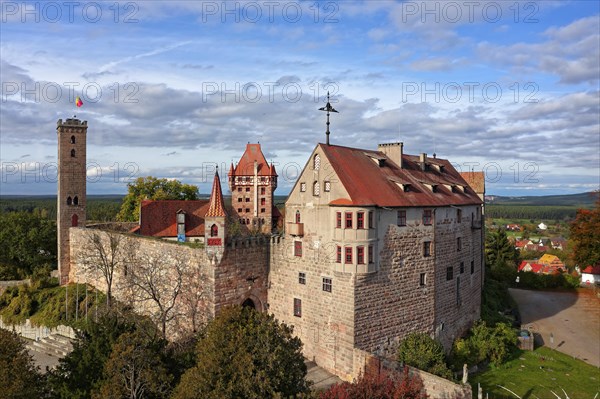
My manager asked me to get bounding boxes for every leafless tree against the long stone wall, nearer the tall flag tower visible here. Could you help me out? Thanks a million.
[79,230,134,307]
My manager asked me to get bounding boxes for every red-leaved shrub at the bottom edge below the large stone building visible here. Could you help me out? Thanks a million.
[320,367,428,399]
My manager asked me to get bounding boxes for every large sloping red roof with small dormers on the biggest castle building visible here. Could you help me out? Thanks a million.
[318,144,482,207]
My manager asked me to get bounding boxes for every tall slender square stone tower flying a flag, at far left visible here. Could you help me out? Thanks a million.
[56,118,87,284]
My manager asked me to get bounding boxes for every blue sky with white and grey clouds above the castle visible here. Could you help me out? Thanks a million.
[0,0,600,196]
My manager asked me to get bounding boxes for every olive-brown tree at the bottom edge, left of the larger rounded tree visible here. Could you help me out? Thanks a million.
[92,330,172,399]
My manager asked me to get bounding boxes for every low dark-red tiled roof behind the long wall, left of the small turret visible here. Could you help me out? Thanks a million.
[139,200,209,237]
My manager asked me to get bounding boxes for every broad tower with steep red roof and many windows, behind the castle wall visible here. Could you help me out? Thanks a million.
[229,143,279,234]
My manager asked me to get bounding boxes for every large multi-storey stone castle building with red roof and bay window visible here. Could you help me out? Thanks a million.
[269,143,483,378]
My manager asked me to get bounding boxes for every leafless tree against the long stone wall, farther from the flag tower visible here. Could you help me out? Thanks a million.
[126,252,188,338]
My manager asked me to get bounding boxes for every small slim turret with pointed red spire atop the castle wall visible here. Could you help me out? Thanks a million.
[204,171,227,259]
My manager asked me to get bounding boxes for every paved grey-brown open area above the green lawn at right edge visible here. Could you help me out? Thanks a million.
[509,288,600,367]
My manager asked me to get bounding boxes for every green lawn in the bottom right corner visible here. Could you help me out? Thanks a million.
[469,347,600,399]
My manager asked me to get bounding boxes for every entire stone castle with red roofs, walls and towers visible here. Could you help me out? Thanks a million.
[57,119,484,379]
